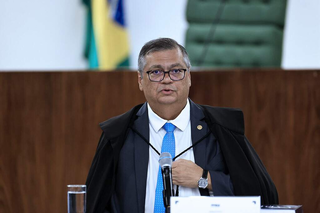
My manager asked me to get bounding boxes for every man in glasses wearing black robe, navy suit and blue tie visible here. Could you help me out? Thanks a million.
[86,38,278,213]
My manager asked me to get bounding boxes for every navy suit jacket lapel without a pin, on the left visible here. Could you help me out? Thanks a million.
[133,103,149,212]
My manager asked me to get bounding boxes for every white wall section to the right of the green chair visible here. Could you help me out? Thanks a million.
[282,0,320,69]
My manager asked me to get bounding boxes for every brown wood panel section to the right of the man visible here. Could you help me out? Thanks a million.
[190,71,320,213]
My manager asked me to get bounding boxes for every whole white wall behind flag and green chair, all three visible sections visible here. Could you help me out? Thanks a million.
[0,0,320,70]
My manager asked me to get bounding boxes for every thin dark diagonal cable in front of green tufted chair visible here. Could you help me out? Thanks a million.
[196,0,226,67]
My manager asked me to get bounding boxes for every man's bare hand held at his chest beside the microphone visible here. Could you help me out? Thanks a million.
[172,159,203,188]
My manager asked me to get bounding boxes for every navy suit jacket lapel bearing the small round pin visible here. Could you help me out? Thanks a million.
[190,100,208,168]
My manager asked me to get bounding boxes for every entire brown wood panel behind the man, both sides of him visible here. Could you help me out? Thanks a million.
[0,70,320,213]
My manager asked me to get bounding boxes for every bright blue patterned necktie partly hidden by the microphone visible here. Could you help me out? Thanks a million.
[154,123,176,213]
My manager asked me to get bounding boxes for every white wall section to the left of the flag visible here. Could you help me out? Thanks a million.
[0,0,86,70]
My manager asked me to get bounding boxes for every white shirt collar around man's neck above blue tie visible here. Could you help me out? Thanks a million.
[147,101,190,132]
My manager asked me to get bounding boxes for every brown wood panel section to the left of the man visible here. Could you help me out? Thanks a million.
[0,72,144,213]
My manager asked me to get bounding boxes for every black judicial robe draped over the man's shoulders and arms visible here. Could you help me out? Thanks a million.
[86,101,278,213]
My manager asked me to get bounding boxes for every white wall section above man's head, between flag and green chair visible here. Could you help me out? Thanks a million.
[125,0,187,69]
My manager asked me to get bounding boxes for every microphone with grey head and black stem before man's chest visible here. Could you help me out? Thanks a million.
[159,152,174,212]
